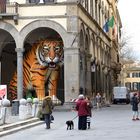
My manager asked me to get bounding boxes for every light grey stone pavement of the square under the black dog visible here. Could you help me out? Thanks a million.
[2,104,140,140]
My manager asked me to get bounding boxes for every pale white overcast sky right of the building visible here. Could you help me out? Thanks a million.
[118,0,140,61]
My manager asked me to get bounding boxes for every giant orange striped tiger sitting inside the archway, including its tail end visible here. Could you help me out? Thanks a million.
[9,39,63,100]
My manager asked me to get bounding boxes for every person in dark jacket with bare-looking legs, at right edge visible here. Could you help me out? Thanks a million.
[131,93,139,121]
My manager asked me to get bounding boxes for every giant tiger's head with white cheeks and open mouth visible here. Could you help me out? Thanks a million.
[36,40,63,68]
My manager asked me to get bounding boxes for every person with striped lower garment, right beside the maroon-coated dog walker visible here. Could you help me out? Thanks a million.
[86,96,93,129]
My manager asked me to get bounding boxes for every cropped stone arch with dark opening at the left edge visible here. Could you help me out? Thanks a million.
[0,22,19,89]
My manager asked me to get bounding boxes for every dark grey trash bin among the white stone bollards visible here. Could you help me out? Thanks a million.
[12,100,19,115]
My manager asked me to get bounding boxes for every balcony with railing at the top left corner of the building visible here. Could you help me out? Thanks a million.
[0,2,19,24]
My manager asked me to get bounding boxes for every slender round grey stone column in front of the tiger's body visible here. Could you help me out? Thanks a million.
[15,48,24,100]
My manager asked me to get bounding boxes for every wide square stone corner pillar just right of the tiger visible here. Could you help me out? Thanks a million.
[64,48,80,102]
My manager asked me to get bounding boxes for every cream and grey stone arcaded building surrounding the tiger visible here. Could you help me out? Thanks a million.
[0,0,121,102]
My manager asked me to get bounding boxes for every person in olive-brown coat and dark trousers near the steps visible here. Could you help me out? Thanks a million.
[42,96,53,129]
